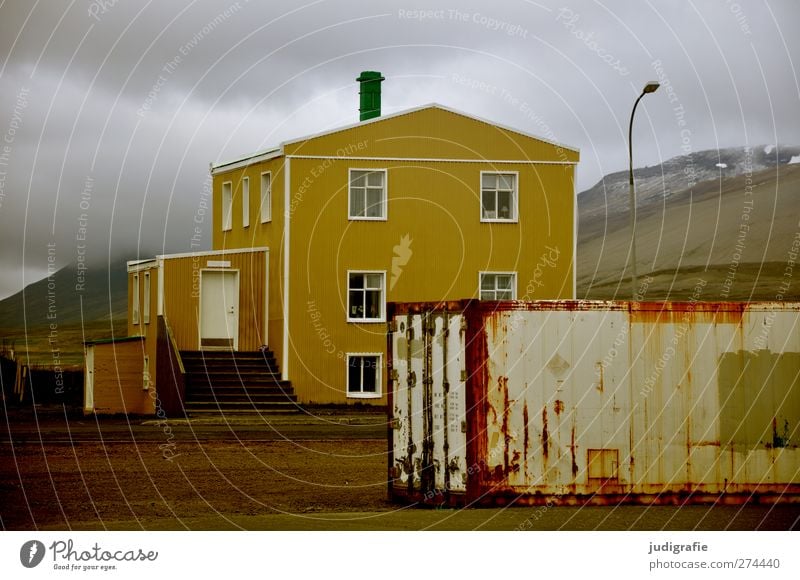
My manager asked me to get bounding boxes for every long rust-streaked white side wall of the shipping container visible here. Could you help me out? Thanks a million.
[392,302,800,503]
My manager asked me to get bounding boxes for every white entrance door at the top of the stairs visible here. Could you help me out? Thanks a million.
[200,270,239,350]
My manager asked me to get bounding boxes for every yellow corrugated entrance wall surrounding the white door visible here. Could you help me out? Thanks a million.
[162,252,266,351]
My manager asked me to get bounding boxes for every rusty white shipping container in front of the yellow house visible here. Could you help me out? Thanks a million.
[387,300,800,506]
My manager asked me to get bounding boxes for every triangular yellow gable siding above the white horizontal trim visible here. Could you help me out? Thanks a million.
[284,108,578,162]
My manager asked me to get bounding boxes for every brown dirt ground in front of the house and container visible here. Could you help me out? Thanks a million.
[0,408,800,530]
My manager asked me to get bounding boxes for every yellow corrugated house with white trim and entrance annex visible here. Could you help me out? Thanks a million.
[84,73,578,412]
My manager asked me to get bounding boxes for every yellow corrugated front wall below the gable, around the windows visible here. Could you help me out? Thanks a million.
[290,159,574,404]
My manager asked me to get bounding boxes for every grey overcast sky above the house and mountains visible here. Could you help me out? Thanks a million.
[0,0,800,297]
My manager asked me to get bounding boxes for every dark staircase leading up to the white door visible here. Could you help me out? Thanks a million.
[181,350,300,416]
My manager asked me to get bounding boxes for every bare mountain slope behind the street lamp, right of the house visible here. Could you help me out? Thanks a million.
[577,155,800,300]
